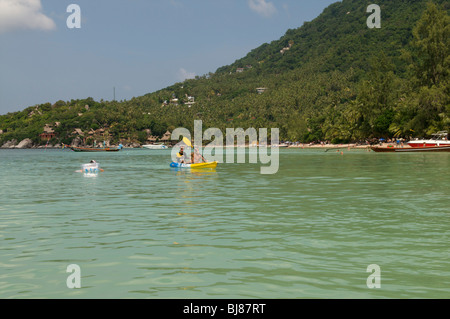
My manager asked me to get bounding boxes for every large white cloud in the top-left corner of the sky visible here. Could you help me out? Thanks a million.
[0,0,56,33]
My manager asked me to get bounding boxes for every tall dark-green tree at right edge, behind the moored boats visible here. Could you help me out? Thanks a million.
[394,2,450,135]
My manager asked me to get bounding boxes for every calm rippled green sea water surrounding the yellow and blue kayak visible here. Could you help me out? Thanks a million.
[0,149,450,299]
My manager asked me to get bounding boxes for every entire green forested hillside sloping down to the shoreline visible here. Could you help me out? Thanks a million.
[0,0,450,145]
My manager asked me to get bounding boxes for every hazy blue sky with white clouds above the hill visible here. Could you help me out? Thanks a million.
[0,0,336,114]
